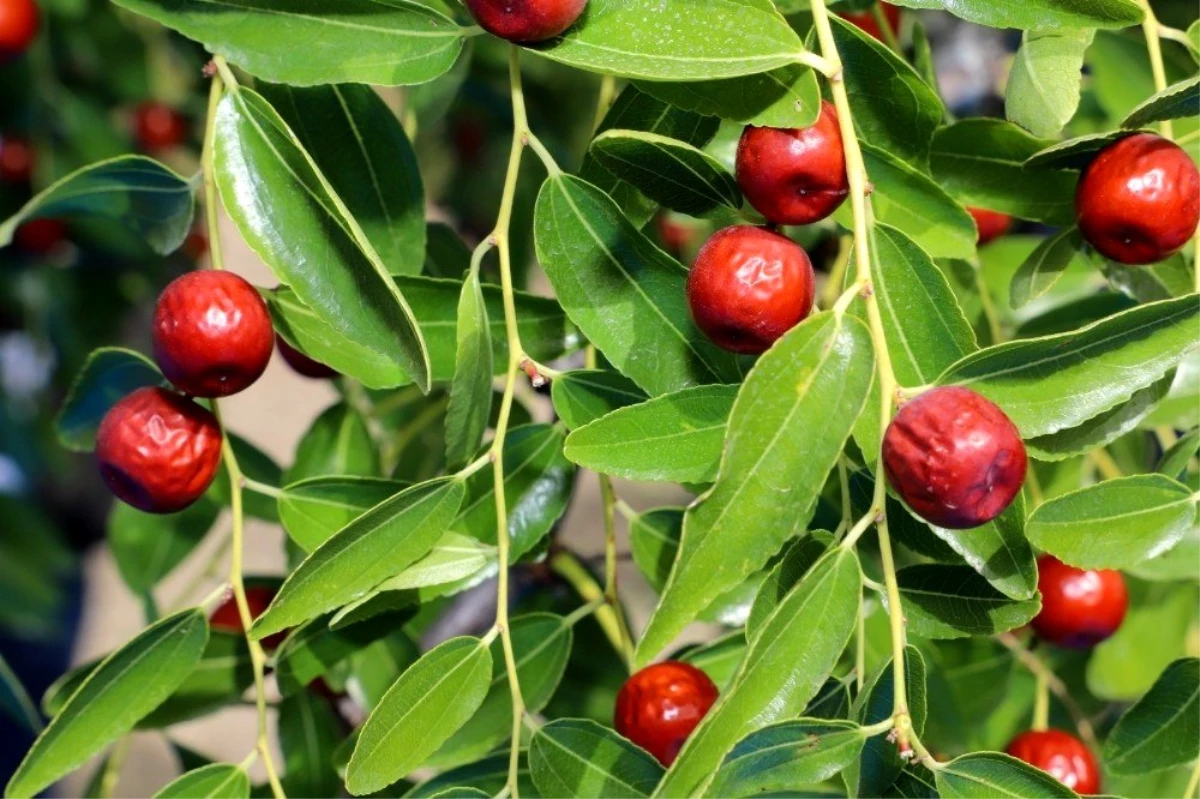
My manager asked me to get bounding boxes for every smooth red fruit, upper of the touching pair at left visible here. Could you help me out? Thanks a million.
[154,270,275,397]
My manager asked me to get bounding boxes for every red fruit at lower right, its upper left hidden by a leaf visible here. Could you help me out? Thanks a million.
[1032,555,1129,649]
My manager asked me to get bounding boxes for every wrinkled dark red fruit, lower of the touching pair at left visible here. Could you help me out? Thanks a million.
[96,386,221,513]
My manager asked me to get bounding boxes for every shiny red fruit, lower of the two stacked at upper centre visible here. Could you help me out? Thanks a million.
[688,226,814,354]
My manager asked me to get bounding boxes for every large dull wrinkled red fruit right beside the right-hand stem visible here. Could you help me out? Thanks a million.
[883,386,1028,530]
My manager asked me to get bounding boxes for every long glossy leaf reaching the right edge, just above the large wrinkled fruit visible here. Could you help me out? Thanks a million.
[937,295,1200,438]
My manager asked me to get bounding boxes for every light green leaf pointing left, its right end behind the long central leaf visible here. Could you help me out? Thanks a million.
[563,385,740,482]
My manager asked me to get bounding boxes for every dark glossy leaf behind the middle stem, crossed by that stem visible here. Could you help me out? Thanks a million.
[454,425,575,563]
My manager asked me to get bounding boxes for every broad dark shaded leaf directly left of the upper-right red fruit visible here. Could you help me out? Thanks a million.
[931,118,1079,224]
